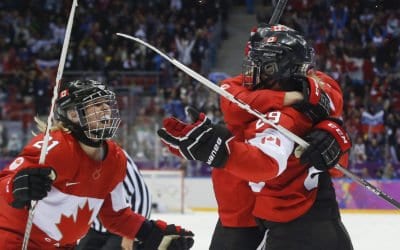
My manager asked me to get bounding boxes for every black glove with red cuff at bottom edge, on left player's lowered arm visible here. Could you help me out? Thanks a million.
[136,220,194,250]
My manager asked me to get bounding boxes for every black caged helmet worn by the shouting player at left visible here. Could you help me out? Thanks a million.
[55,80,121,146]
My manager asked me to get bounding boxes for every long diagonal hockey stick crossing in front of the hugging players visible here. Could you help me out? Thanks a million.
[117,33,400,209]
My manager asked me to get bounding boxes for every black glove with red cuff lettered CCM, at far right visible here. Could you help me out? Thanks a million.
[300,118,352,171]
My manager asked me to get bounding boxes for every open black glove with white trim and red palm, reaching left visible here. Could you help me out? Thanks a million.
[157,107,233,167]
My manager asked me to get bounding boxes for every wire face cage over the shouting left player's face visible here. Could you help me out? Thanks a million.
[77,94,121,140]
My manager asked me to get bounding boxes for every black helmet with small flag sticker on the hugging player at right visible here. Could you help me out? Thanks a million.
[243,24,315,89]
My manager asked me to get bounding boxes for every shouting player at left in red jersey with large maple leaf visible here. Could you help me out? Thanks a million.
[0,80,193,250]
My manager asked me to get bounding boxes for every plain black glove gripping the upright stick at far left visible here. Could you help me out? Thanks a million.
[11,166,55,208]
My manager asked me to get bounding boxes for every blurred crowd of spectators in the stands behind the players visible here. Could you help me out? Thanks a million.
[0,0,400,179]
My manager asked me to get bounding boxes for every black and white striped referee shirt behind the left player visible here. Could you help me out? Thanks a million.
[91,151,151,233]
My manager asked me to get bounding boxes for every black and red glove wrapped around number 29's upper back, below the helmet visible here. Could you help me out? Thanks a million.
[293,76,331,124]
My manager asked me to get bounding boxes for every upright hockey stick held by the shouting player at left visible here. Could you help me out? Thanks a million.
[22,0,78,250]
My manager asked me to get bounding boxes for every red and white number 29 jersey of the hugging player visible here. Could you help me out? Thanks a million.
[225,108,317,222]
